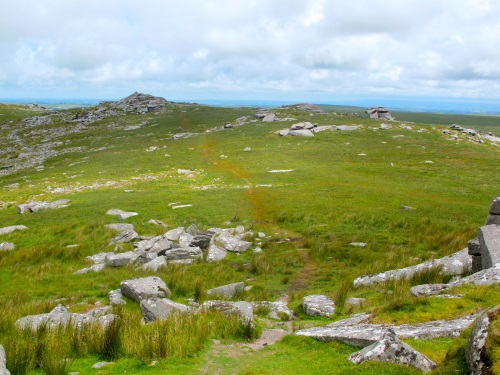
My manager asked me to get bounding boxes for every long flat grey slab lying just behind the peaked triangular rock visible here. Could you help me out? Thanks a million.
[295,314,477,348]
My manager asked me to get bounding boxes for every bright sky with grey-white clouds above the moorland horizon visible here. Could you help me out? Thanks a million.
[0,0,500,108]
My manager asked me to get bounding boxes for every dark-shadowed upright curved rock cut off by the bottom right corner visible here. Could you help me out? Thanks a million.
[465,306,500,375]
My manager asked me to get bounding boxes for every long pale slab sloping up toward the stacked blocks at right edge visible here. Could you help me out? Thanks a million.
[354,248,472,288]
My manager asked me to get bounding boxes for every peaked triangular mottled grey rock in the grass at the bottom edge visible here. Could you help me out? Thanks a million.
[347,330,436,373]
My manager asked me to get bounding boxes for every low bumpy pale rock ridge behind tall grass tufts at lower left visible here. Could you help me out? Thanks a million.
[16,305,116,331]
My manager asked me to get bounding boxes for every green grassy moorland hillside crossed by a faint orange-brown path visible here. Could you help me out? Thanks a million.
[0,103,500,374]
